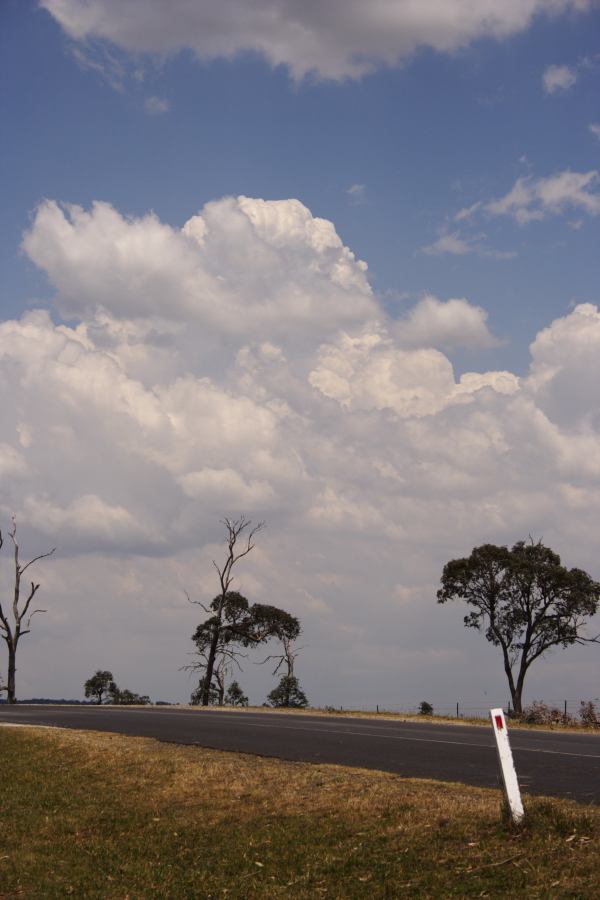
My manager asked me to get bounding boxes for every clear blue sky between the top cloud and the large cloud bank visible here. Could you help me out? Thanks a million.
[2,0,600,371]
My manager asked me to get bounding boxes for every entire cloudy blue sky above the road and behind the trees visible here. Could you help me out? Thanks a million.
[0,0,600,709]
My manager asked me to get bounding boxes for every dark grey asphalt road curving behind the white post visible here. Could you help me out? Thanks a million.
[0,705,600,804]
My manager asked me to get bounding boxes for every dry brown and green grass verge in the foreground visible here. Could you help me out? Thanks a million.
[0,727,600,900]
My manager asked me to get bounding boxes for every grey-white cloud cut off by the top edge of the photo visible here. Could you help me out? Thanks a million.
[41,0,591,79]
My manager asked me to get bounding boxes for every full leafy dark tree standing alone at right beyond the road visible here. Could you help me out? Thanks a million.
[437,540,600,714]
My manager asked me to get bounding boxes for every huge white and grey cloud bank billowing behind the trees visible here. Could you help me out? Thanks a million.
[0,198,600,705]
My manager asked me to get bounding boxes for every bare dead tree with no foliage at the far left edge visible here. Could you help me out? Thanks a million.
[0,516,56,703]
